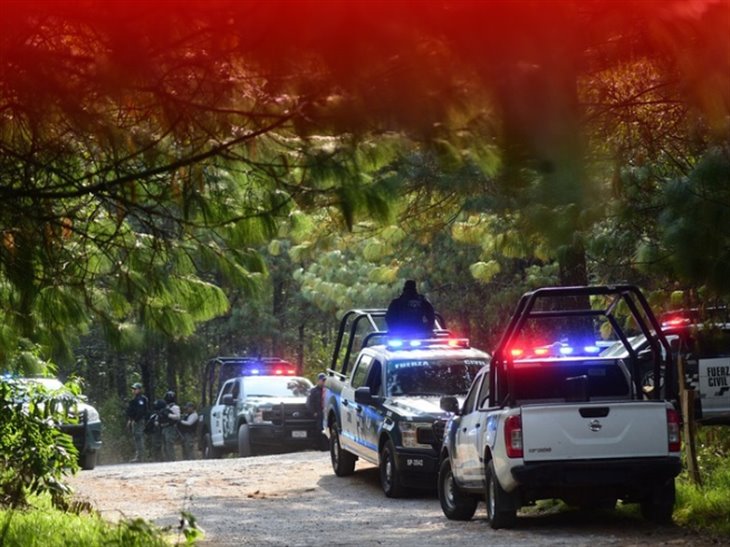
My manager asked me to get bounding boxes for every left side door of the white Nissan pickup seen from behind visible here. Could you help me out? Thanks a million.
[451,374,485,486]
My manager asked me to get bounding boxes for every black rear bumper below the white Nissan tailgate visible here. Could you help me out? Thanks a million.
[512,457,682,491]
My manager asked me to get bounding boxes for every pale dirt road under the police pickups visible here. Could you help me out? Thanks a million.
[71,452,716,547]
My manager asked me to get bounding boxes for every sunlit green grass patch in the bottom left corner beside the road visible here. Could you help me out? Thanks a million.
[0,496,169,547]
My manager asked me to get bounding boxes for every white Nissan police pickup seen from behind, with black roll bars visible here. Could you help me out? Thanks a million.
[438,285,681,528]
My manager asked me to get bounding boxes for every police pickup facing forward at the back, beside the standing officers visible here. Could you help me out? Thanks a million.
[201,357,320,458]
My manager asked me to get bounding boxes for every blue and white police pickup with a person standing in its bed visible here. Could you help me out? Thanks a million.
[324,310,489,497]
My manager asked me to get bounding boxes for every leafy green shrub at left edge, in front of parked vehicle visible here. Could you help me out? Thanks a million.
[0,378,78,507]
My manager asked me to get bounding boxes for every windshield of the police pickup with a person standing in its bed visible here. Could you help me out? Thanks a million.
[386,359,487,396]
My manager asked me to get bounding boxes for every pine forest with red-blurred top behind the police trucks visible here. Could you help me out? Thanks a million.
[0,0,730,462]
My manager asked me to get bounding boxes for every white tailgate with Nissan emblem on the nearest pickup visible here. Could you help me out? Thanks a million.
[522,401,668,462]
